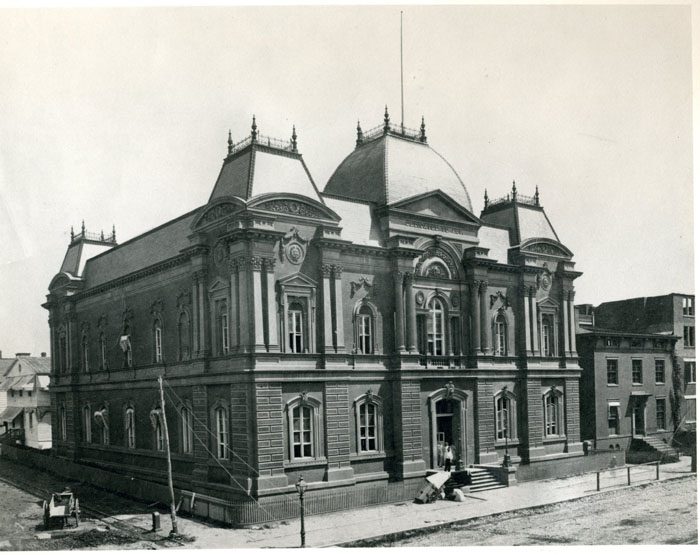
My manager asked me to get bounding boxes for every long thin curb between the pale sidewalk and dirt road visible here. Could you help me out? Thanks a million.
[332,473,697,548]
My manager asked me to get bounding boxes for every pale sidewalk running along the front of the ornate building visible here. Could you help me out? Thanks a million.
[165,457,691,548]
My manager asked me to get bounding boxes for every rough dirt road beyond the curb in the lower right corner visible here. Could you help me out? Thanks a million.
[374,476,698,547]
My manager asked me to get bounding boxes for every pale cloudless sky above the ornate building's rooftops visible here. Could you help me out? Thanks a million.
[0,5,694,357]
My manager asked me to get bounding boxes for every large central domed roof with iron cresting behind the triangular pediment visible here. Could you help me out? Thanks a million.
[323,125,472,212]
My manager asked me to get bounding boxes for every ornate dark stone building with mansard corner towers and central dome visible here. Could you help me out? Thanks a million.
[44,113,582,521]
